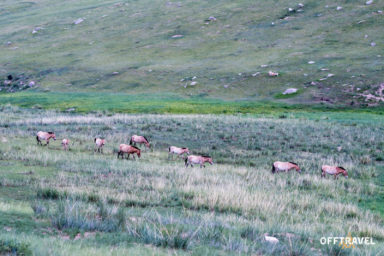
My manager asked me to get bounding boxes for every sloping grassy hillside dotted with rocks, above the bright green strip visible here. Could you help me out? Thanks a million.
[0,0,384,105]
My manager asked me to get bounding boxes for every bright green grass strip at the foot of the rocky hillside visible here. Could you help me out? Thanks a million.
[0,92,384,115]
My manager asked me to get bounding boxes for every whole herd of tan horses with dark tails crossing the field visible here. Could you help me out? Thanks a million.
[36,131,348,179]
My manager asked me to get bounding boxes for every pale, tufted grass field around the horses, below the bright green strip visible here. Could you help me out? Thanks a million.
[0,105,384,255]
